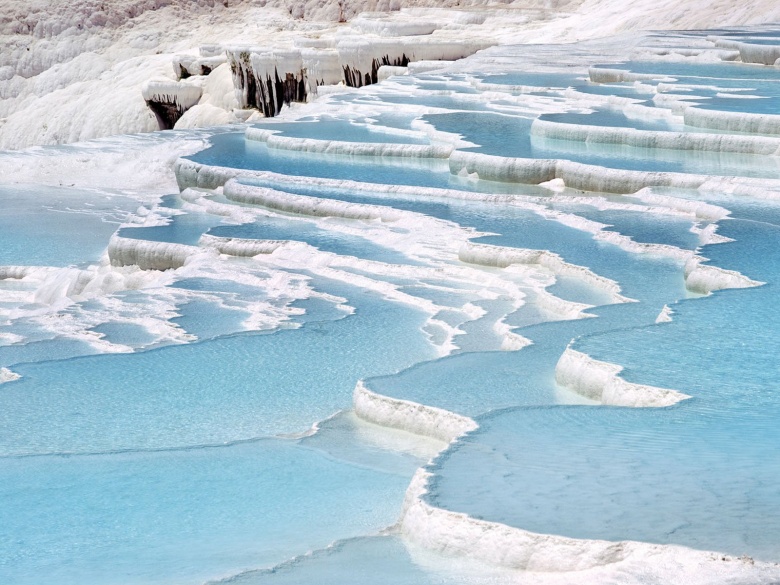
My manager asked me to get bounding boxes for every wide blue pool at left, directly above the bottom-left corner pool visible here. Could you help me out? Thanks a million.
[0,280,434,455]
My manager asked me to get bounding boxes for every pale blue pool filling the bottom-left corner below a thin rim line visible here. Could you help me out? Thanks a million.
[0,439,408,585]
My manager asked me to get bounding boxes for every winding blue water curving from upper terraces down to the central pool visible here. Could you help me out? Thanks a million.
[241,179,692,415]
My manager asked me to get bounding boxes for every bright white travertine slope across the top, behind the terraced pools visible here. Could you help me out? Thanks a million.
[0,0,780,148]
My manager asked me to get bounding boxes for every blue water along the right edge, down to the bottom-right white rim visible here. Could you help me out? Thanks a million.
[431,206,780,560]
